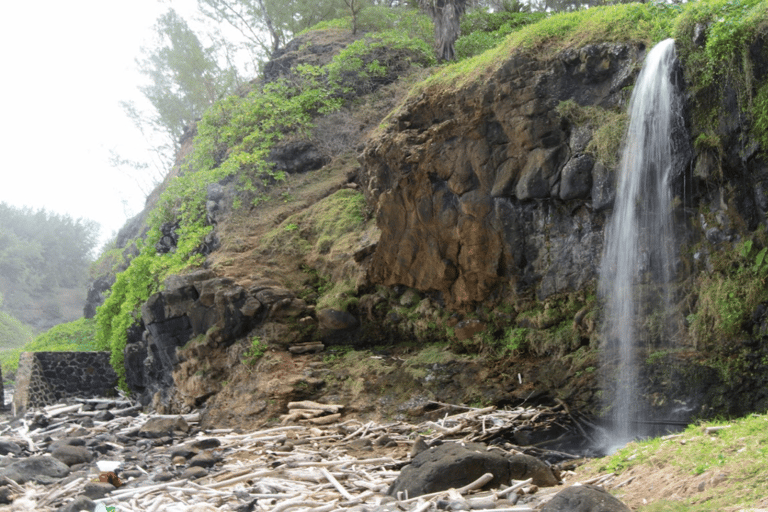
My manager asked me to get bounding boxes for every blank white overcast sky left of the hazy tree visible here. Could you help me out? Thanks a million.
[0,0,210,248]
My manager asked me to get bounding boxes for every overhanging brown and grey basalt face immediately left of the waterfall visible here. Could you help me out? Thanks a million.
[361,44,645,308]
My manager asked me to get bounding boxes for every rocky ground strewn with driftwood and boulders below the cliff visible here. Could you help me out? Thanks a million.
[0,399,640,512]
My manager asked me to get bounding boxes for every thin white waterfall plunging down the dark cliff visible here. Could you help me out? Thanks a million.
[599,39,681,446]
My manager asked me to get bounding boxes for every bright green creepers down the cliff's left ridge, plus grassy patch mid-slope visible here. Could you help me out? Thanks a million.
[97,18,431,377]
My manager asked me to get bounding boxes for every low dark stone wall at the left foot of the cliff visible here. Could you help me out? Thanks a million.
[13,352,117,415]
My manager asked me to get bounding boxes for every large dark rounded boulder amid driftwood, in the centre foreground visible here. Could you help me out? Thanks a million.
[387,443,510,498]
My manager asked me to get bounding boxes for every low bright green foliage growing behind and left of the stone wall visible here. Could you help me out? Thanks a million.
[0,320,99,375]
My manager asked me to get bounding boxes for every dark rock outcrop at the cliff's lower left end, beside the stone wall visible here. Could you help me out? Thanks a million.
[124,270,316,411]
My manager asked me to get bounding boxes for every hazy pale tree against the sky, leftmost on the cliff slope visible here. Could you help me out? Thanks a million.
[120,9,238,171]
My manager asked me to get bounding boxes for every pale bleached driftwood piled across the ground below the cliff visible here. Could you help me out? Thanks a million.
[0,402,592,512]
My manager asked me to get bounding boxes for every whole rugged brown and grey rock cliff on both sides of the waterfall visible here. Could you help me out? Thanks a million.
[87,10,768,434]
